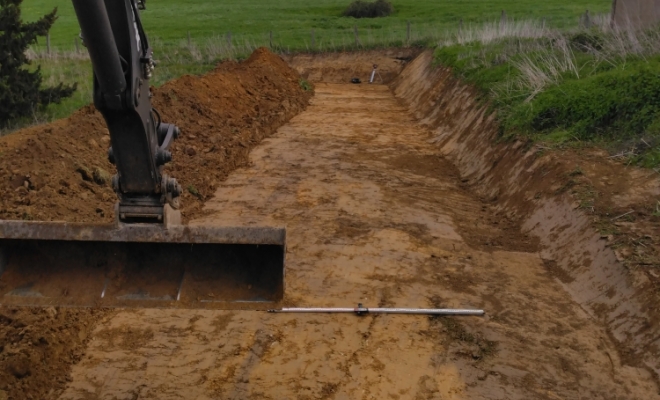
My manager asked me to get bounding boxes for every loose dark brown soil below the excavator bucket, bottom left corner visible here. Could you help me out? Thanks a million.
[0,307,108,399]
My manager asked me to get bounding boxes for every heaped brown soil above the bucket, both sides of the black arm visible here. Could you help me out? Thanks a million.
[0,48,312,222]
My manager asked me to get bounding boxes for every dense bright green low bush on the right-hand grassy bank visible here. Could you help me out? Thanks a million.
[508,61,660,141]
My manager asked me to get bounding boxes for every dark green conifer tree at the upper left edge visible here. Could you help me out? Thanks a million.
[0,0,76,126]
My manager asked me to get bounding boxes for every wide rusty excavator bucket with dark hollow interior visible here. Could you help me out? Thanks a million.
[0,221,286,309]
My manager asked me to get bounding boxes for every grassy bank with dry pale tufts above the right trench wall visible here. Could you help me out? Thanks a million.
[435,21,660,167]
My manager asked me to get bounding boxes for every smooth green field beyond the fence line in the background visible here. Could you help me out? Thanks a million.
[23,0,612,49]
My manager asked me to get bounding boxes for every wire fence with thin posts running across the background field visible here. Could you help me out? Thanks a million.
[28,11,611,62]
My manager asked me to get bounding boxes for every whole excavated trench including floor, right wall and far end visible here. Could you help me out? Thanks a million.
[1,50,659,399]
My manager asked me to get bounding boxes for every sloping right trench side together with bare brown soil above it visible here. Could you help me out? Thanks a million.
[391,52,660,379]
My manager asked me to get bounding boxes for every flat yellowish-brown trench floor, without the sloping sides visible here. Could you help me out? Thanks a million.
[61,84,658,399]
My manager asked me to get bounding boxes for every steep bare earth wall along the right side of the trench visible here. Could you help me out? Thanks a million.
[390,51,660,378]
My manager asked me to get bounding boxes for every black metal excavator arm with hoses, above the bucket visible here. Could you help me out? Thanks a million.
[72,0,181,222]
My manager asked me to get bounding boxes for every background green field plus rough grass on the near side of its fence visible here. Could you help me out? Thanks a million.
[5,0,611,134]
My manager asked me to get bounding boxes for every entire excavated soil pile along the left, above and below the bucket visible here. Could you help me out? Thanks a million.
[0,49,312,399]
